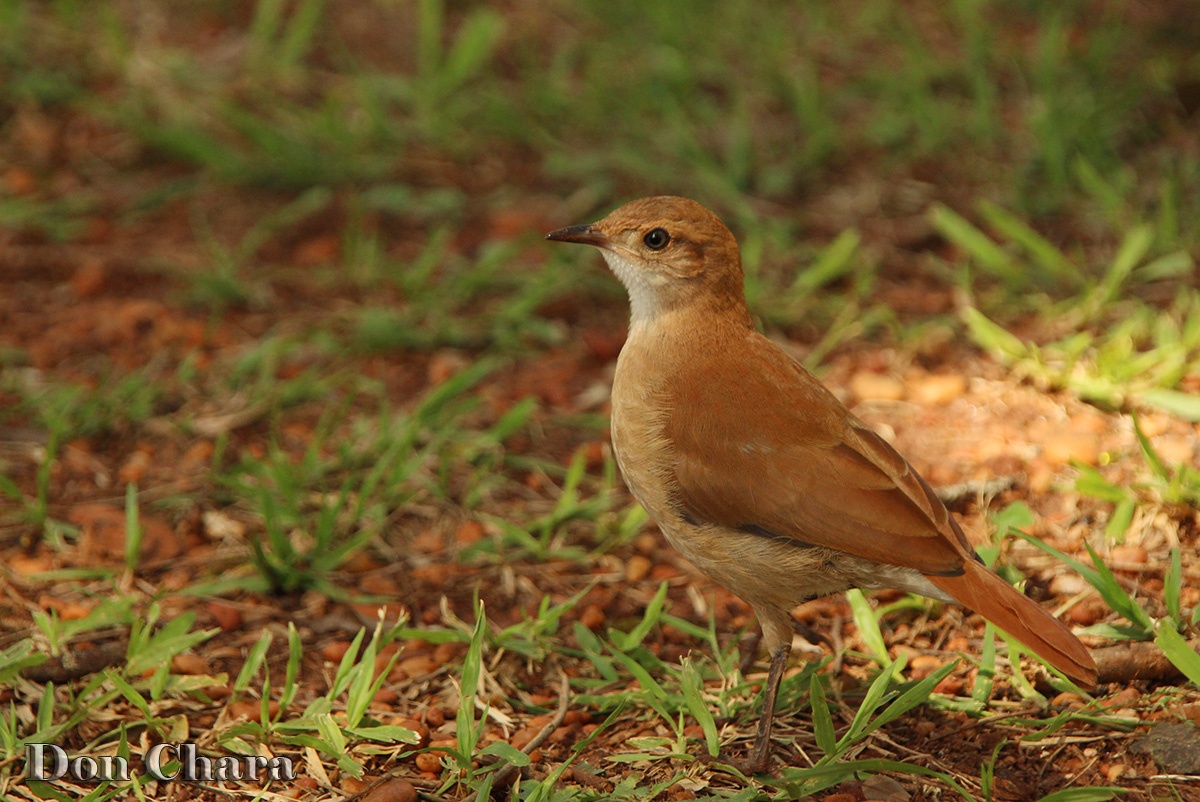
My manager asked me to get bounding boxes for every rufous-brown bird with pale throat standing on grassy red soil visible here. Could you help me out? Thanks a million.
[546,196,1097,773]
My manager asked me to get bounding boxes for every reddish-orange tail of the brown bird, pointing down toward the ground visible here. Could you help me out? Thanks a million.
[928,559,1096,688]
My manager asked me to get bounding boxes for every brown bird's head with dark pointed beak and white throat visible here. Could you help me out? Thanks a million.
[546,196,745,325]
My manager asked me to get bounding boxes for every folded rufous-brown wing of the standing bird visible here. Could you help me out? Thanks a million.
[667,335,973,576]
